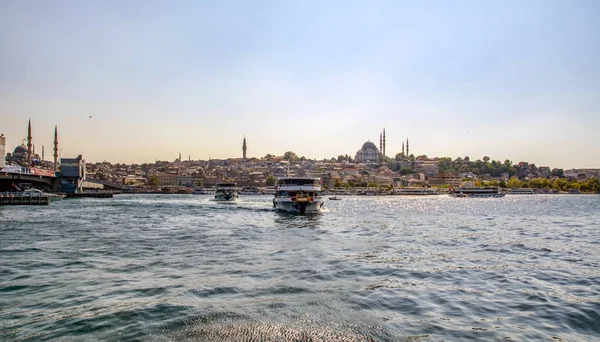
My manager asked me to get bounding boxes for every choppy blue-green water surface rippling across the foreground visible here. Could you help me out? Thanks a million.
[0,195,600,341]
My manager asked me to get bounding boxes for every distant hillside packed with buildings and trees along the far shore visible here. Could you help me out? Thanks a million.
[86,152,600,192]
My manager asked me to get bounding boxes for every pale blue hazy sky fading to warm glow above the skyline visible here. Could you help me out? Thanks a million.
[0,0,600,168]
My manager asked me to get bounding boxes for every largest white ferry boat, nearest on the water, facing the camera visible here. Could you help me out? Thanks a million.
[273,177,325,214]
